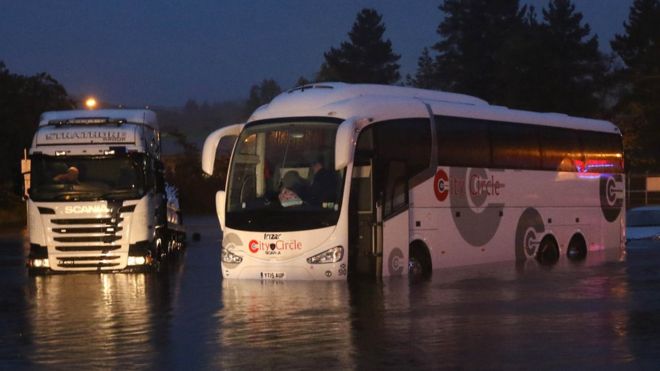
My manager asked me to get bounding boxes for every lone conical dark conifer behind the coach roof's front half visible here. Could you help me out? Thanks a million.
[317,9,401,84]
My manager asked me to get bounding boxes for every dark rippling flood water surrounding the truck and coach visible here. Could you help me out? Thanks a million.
[0,217,660,369]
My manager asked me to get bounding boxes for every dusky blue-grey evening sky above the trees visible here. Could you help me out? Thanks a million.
[0,0,632,106]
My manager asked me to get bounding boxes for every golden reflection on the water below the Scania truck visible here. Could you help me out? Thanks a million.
[28,274,159,368]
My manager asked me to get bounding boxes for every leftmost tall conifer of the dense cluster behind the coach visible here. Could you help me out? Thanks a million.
[433,0,523,102]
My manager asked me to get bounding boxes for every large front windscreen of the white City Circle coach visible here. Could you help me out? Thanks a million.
[226,121,344,231]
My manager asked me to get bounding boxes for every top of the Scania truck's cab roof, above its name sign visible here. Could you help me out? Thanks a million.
[39,109,158,130]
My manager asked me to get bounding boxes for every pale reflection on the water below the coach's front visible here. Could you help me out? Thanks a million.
[216,281,353,369]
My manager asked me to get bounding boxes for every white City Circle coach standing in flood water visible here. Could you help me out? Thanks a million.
[202,83,625,280]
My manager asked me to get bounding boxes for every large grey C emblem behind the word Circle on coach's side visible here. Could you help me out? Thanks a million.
[449,167,504,246]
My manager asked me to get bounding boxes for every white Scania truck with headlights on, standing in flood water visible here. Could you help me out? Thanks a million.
[21,109,185,274]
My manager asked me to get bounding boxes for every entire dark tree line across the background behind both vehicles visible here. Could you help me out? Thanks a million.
[0,0,660,218]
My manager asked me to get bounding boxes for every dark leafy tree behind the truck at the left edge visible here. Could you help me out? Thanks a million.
[0,62,75,199]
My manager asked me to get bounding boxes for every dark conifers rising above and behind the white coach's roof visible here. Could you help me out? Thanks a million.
[315,0,660,171]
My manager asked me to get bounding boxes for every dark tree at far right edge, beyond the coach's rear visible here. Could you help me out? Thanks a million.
[611,0,660,171]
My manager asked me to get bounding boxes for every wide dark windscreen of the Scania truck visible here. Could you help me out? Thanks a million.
[29,155,148,201]
